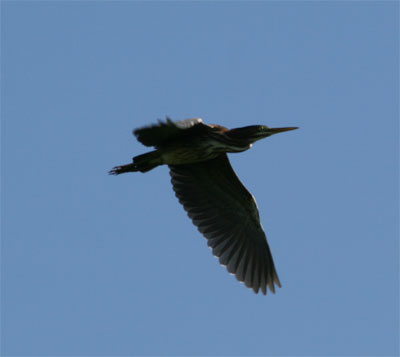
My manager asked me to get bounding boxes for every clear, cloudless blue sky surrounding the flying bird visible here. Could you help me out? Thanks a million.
[1,1,399,356]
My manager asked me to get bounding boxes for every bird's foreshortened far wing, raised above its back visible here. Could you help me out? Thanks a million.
[133,117,208,148]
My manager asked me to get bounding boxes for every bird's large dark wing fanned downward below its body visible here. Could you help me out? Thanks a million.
[169,154,281,294]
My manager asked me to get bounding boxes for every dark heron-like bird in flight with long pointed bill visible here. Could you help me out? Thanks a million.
[109,117,298,295]
